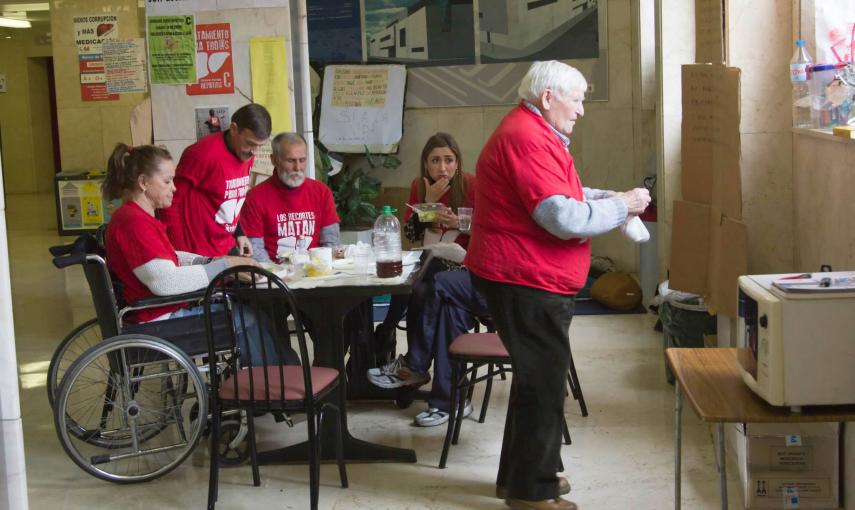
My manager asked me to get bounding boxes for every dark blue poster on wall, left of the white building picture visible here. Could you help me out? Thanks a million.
[306,0,362,65]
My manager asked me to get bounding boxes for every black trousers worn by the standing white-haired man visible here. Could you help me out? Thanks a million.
[472,274,575,501]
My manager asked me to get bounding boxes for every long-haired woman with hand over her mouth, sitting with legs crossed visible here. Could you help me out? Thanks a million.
[367,133,489,427]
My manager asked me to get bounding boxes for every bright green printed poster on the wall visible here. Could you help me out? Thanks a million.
[146,15,196,84]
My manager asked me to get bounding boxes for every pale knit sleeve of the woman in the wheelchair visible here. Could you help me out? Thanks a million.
[134,259,229,296]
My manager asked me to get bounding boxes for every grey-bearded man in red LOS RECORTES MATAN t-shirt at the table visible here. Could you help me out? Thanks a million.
[240,133,339,262]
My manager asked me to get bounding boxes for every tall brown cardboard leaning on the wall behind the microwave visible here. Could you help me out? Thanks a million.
[670,64,748,317]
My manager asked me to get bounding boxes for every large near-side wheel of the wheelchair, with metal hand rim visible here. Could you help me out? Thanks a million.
[54,335,208,483]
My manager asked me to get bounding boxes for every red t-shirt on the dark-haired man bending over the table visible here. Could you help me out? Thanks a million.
[158,132,253,257]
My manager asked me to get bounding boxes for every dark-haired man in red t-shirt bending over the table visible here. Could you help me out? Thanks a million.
[158,103,271,257]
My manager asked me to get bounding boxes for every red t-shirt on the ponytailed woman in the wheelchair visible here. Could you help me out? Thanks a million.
[106,200,186,322]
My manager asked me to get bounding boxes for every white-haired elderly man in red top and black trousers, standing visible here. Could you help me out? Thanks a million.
[465,61,650,510]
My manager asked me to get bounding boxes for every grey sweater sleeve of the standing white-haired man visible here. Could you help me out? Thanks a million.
[532,195,627,239]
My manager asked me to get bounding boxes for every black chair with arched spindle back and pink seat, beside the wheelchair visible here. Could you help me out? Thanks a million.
[204,266,347,510]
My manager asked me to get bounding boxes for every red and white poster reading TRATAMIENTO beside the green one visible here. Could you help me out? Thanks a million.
[187,23,235,96]
